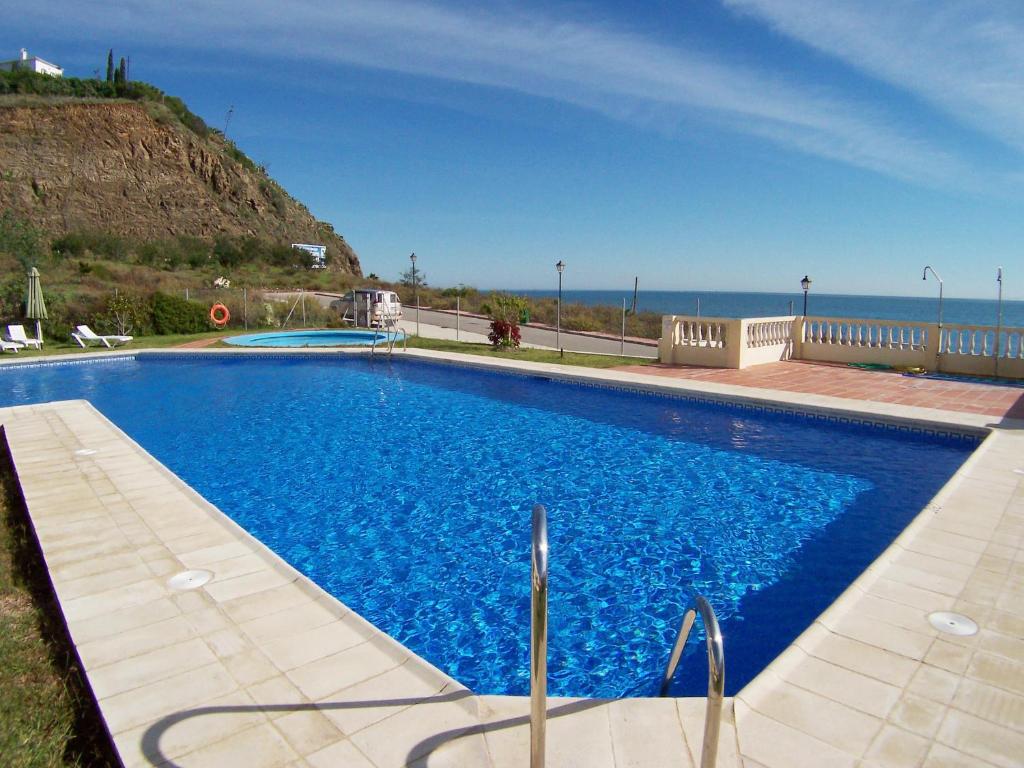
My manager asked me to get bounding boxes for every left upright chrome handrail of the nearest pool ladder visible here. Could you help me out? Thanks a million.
[529,504,548,768]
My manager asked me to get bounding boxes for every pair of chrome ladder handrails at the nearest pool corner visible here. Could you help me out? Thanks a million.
[529,504,725,768]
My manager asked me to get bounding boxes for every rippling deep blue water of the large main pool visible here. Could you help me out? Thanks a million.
[0,354,976,696]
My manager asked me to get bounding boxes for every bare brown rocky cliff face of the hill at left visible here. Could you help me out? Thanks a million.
[0,96,361,275]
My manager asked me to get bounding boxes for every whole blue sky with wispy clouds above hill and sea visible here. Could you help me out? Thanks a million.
[0,0,1024,299]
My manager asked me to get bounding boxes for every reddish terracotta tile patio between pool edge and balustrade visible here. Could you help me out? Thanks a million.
[615,360,1024,419]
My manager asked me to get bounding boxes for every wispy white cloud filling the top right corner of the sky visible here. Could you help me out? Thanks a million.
[723,0,1024,150]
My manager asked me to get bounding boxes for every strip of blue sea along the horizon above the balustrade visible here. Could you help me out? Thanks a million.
[514,291,1024,328]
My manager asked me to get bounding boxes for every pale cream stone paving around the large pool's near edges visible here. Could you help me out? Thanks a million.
[0,350,1024,768]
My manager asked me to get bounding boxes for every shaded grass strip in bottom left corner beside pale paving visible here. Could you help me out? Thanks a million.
[0,433,118,768]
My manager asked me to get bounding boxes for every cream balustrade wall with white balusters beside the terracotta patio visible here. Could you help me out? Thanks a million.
[658,315,1024,378]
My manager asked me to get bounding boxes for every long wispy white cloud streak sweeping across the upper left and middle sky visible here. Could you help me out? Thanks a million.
[25,0,1011,185]
